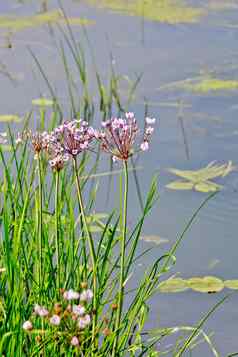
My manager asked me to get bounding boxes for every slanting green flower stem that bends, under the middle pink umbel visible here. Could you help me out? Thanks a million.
[74,158,97,347]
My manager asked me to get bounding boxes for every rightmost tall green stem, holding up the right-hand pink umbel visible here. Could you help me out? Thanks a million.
[112,161,128,357]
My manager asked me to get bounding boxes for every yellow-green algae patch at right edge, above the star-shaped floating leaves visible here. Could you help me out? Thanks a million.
[181,78,238,93]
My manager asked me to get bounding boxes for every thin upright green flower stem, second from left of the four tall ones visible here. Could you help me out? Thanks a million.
[55,171,60,293]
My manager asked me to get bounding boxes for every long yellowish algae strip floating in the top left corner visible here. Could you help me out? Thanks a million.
[0,9,93,32]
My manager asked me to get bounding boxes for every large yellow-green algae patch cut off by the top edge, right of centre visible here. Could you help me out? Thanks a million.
[87,0,207,24]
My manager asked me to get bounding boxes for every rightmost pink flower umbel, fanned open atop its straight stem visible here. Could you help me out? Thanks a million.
[96,112,155,161]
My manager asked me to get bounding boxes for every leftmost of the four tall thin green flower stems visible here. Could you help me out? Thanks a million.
[37,153,43,296]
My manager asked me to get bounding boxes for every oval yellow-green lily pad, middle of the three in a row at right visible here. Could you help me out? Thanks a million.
[187,276,224,293]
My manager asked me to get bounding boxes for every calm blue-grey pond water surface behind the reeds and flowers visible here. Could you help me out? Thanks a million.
[0,0,238,357]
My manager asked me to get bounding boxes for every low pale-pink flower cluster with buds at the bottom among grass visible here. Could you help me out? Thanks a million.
[22,283,93,346]
